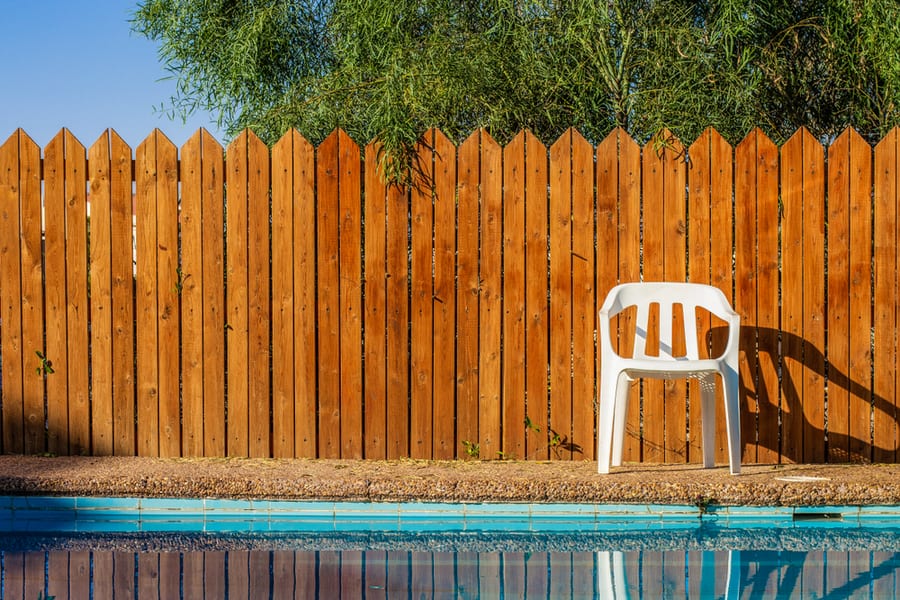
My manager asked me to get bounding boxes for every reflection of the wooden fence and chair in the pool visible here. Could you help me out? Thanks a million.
[0,548,900,600]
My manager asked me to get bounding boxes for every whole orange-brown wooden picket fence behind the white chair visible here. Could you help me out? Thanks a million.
[0,130,900,463]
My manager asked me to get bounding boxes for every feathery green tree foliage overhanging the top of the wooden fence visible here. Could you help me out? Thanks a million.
[132,0,900,181]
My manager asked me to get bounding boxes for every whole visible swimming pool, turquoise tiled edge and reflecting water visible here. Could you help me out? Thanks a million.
[0,497,900,599]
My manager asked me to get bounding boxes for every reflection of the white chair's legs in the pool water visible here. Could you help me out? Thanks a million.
[596,550,741,600]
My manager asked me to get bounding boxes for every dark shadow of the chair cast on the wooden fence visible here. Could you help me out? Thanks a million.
[707,327,900,463]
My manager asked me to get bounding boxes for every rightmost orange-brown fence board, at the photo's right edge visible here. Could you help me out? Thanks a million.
[872,128,900,462]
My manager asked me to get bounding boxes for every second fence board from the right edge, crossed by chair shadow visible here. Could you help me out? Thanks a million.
[852,129,874,462]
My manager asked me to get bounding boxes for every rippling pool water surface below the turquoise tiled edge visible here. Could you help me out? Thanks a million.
[0,527,900,600]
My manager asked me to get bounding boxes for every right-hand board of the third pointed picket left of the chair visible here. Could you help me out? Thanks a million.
[478,131,504,458]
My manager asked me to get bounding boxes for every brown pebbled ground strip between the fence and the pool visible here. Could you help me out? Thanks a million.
[0,455,900,506]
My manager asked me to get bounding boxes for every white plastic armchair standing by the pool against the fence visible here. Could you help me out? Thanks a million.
[597,282,741,475]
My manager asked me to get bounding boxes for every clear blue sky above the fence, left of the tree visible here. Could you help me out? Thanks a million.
[0,0,226,148]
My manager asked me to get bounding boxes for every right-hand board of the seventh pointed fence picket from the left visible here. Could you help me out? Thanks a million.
[291,130,319,458]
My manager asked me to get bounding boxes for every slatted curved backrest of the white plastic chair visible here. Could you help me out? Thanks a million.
[600,282,733,360]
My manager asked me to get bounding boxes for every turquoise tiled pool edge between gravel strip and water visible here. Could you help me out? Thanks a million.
[0,496,900,533]
